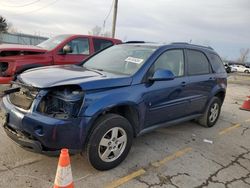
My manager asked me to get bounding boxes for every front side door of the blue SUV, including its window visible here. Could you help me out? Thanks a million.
[143,49,188,128]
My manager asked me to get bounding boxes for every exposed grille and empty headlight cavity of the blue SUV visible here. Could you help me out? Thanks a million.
[5,82,84,119]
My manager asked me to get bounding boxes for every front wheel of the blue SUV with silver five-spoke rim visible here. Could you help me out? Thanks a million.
[86,114,133,171]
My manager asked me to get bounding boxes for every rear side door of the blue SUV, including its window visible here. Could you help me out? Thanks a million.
[185,49,216,115]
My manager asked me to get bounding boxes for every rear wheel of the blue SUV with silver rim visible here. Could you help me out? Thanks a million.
[198,97,222,127]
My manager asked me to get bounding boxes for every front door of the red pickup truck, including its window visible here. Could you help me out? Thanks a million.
[54,37,90,64]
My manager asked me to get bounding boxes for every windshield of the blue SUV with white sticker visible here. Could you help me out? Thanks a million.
[83,45,157,75]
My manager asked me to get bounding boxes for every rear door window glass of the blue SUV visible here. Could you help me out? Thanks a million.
[187,50,210,75]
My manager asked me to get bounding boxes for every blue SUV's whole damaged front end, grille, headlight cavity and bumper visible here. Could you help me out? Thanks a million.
[1,82,88,155]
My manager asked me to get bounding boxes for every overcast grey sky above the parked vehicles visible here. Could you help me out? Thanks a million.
[0,0,250,60]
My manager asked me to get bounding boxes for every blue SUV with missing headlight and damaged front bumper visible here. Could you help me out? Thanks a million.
[1,43,227,170]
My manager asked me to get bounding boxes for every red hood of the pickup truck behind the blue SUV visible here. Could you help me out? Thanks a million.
[0,44,47,52]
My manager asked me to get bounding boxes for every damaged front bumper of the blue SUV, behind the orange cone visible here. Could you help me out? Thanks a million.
[1,95,90,155]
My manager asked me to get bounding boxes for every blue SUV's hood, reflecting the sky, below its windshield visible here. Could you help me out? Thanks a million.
[18,65,132,90]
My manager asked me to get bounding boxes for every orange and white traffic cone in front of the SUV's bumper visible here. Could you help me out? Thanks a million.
[54,149,74,188]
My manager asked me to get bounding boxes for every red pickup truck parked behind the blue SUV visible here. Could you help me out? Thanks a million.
[0,35,122,84]
